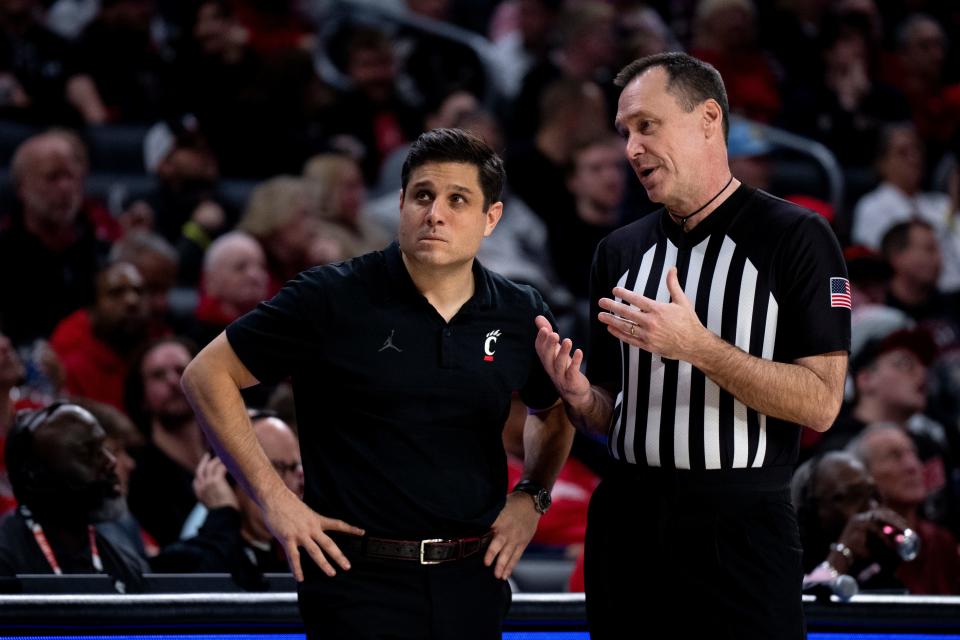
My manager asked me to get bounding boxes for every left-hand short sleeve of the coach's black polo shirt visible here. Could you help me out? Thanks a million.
[227,271,322,383]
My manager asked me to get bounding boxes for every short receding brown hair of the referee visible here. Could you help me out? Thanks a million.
[613,51,730,140]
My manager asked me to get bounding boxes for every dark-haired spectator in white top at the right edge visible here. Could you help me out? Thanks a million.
[851,123,960,293]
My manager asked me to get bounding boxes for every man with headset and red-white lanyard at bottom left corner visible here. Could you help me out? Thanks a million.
[0,403,147,592]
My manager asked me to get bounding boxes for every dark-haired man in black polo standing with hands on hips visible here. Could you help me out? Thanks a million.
[183,129,573,638]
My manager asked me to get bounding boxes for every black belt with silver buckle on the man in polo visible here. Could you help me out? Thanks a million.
[331,531,493,564]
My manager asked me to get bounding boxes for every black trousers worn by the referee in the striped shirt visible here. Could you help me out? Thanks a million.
[584,468,806,640]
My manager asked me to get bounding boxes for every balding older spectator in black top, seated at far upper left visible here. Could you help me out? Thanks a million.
[0,132,107,345]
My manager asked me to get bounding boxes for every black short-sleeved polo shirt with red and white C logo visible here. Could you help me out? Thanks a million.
[227,243,557,538]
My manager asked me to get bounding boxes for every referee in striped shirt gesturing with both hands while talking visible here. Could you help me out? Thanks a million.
[537,53,851,640]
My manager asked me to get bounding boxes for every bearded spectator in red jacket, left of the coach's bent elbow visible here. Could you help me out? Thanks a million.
[50,262,149,409]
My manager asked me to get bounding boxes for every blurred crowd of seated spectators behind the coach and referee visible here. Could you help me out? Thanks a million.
[0,0,960,593]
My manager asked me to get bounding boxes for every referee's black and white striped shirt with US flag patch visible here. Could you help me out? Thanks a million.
[587,186,850,469]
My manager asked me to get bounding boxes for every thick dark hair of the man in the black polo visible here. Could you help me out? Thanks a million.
[400,129,506,211]
